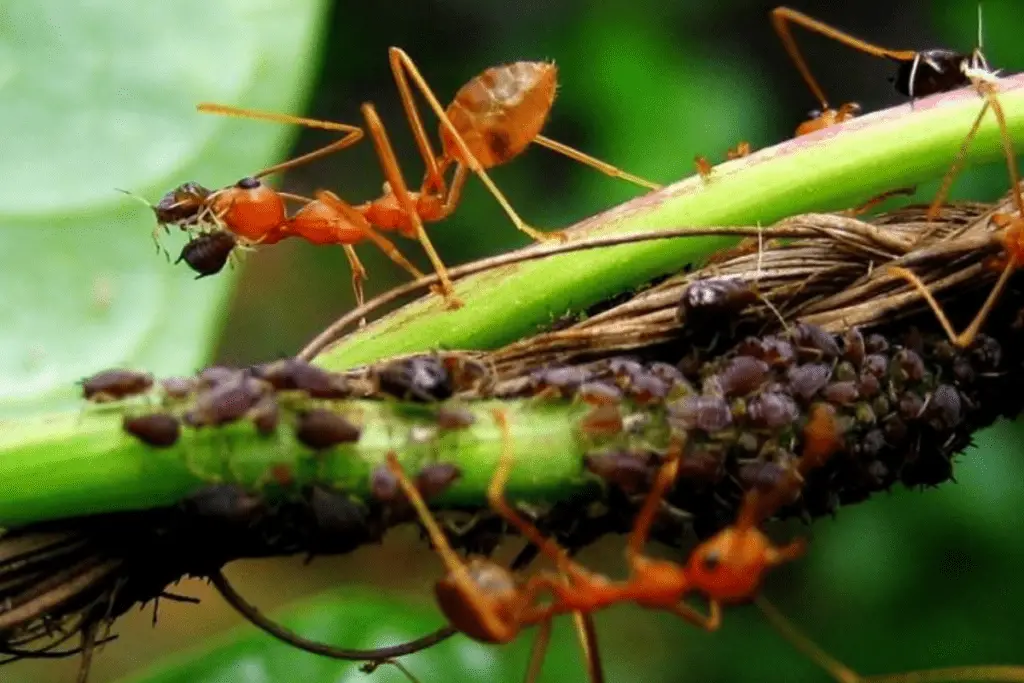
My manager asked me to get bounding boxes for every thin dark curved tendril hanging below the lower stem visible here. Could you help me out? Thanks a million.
[210,570,458,661]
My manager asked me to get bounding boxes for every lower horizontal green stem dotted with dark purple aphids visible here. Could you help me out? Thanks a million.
[0,400,587,526]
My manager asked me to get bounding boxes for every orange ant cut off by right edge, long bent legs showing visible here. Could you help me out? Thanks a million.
[888,76,1024,348]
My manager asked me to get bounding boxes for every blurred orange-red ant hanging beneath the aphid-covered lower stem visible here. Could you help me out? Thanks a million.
[387,405,839,681]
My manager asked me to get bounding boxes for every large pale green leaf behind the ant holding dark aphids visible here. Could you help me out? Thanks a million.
[0,0,324,415]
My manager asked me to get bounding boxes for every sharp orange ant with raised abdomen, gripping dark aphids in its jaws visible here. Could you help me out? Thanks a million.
[192,47,660,307]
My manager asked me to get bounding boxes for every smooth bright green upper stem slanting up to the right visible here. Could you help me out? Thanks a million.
[317,76,1024,370]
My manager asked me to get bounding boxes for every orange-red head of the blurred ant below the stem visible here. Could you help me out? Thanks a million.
[685,527,774,602]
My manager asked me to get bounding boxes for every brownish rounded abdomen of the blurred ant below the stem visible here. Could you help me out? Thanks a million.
[434,558,519,643]
